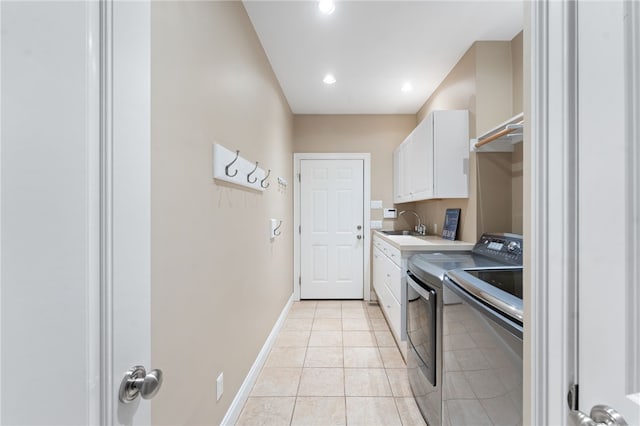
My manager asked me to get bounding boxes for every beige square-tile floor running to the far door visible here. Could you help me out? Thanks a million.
[236,301,425,426]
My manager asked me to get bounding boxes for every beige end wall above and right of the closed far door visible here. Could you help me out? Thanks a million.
[293,114,417,228]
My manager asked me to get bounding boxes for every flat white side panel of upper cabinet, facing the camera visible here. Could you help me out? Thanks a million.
[431,111,469,198]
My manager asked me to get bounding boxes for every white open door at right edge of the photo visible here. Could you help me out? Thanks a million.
[577,1,640,425]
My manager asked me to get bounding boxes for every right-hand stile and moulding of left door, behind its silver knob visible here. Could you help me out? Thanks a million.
[110,0,154,426]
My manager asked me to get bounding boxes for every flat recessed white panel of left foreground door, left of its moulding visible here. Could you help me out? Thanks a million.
[0,1,100,425]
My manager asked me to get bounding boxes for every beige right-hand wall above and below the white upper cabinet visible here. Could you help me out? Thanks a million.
[412,33,522,242]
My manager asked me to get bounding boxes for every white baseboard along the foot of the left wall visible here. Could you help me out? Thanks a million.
[220,294,293,426]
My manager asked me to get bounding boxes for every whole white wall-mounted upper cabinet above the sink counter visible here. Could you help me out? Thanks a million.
[393,110,469,203]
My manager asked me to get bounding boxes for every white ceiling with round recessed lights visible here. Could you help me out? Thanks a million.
[244,0,523,114]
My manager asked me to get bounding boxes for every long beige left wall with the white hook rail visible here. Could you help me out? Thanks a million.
[151,1,293,425]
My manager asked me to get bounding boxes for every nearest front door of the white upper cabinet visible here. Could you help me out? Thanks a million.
[406,114,434,201]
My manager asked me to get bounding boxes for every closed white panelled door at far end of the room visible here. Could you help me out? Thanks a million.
[300,159,368,299]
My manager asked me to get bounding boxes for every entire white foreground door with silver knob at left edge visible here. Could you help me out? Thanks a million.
[0,1,150,425]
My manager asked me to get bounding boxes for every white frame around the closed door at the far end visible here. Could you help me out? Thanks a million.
[293,152,371,301]
